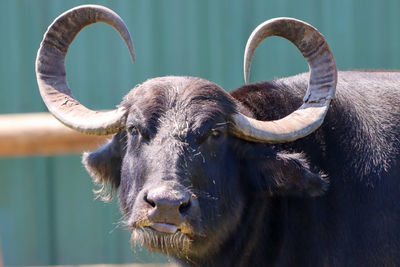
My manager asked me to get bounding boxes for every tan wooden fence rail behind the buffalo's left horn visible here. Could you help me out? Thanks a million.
[0,113,111,157]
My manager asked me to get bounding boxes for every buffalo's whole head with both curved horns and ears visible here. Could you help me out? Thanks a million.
[36,5,337,261]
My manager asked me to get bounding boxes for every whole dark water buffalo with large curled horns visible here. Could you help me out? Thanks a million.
[36,6,400,266]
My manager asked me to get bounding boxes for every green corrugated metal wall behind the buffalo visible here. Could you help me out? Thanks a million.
[0,0,400,265]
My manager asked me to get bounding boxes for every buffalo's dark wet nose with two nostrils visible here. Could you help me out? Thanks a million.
[144,187,191,222]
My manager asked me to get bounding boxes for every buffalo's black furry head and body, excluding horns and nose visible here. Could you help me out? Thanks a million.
[83,72,400,266]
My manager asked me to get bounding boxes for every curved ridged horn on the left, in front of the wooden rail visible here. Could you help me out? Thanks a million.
[36,5,135,135]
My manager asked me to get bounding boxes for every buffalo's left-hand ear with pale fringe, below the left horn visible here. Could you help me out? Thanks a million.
[82,133,125,201]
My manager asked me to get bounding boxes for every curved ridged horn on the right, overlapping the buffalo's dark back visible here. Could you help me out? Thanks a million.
[233,18,337,143]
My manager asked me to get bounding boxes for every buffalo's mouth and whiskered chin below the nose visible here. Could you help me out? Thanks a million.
[131,222,194,257]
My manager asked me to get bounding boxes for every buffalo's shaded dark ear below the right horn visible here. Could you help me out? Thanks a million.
[250,152,329,197]
